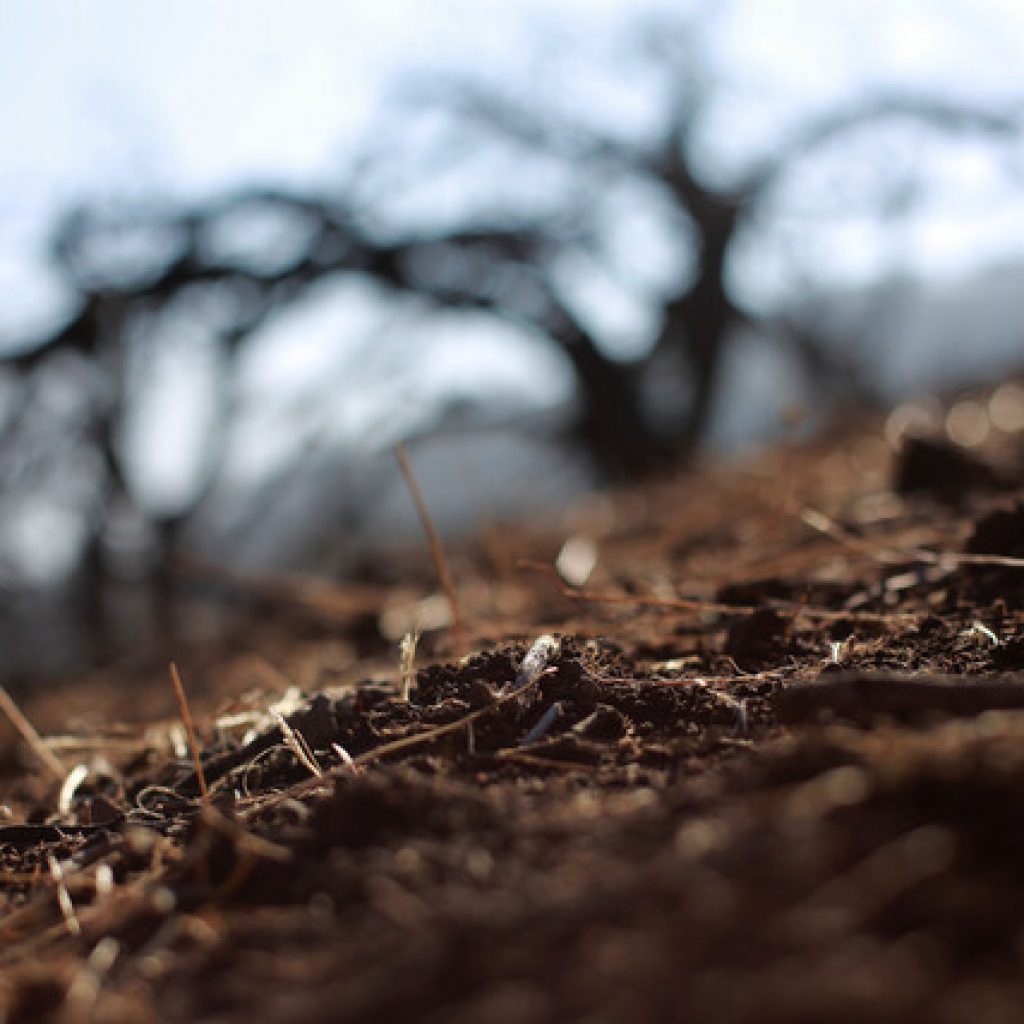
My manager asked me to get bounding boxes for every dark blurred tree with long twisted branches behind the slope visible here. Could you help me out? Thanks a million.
[0,19,1019,667]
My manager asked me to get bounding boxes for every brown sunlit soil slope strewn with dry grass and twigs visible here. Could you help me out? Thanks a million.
[0,403,1024,1024]
